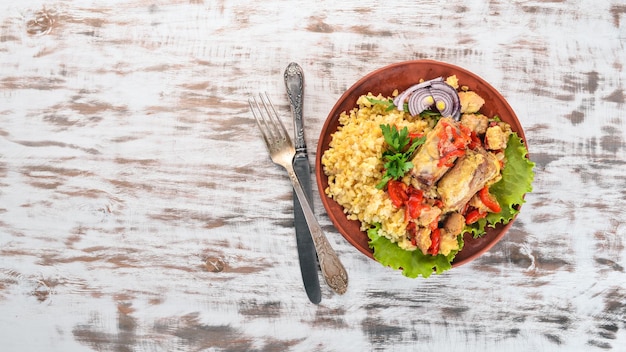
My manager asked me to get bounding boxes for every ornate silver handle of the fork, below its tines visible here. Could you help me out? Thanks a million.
[287,164,348,294]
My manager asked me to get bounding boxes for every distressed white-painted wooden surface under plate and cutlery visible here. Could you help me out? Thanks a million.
[0,0,626,351]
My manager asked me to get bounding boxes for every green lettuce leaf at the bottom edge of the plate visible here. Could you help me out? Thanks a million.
[367,224,463,278]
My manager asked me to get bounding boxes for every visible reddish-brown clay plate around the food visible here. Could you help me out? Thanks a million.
[315,60,526,267]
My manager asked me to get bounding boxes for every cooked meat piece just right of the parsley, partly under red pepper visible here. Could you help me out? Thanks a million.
[411,117,460,191]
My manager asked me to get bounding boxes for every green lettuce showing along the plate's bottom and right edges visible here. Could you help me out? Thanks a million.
[367,133,535,278]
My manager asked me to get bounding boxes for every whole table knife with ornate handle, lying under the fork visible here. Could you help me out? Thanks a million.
[284,62,322,304]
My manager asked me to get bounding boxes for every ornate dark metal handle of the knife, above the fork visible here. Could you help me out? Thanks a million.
[285,62,306,155]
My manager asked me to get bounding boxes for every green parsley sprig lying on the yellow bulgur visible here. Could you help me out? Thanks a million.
[376,125,426,189]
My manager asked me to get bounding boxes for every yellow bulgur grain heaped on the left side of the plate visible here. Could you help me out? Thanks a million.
[322,93,429,249]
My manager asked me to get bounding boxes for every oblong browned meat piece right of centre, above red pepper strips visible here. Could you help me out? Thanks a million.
[437,148,500,213]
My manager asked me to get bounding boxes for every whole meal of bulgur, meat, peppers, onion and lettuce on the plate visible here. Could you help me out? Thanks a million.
[321,76,534,277]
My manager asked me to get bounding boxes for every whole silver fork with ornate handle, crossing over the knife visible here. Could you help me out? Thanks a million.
[248,93,348,294]
